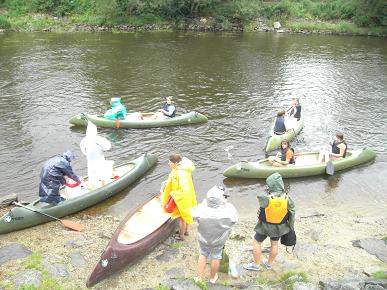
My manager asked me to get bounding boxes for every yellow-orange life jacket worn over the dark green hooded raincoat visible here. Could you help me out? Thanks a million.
[259,193,289,225]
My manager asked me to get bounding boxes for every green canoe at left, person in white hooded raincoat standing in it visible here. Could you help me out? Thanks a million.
[0,153,157,234]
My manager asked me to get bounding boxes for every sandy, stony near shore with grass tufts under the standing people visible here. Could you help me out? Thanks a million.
[0,205,387,289]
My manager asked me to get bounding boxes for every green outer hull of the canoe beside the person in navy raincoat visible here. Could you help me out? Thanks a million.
[0,153,157,234]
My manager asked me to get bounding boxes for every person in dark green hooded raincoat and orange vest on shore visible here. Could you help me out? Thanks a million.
[243,173,296,271]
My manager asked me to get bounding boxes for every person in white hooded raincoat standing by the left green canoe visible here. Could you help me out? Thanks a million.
[80,121,114,186]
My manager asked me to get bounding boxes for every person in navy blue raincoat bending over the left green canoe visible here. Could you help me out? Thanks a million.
[39,150,81,205]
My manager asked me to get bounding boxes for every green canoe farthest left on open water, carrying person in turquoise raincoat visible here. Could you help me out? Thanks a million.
[69,112,208,129]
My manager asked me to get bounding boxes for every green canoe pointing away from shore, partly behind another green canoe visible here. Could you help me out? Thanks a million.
[265,107,304,152]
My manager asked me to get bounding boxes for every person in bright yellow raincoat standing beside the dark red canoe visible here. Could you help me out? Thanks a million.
[163,154,196,240]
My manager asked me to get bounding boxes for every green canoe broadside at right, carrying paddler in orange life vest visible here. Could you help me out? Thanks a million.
[223,148,376,178]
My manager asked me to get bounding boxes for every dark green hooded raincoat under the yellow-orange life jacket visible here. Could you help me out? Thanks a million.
[254,173,296,238]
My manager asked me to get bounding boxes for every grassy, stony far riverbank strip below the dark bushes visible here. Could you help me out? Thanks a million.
[0,13,387,37]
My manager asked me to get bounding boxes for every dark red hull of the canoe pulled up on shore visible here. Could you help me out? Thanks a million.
[86,194,177,287]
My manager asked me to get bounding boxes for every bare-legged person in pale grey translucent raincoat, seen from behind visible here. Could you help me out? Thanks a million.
[191,186,238,283]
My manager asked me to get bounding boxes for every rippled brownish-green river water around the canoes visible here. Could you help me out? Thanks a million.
[0,32,387,216]
